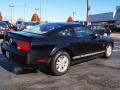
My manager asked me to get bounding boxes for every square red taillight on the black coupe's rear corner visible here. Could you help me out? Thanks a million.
[17,40,30,52]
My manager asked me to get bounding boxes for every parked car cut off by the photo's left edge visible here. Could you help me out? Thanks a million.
[0,21,9,38]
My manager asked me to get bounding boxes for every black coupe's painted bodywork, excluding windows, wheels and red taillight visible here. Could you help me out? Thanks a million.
[1,24,113,67]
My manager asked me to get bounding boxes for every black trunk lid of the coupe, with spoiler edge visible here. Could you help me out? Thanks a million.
[4,31,44,49]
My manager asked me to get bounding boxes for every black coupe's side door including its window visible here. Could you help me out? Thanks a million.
[74,26,102,55]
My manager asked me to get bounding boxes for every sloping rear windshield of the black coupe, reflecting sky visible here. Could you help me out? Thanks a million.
[26,24,60,34]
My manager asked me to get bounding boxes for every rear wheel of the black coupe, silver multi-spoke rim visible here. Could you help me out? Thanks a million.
[50,50,71,76]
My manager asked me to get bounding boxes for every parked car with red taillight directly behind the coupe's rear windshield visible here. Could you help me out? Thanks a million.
[19,22,39,30]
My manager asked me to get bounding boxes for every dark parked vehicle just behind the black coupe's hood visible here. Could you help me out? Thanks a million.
[89,25,111,36]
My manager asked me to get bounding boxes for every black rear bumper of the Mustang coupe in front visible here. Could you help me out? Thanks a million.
[1,43,49,67]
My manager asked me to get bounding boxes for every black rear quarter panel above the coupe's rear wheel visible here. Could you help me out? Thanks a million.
[31,36,73,58]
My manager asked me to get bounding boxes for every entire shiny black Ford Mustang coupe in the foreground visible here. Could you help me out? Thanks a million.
[1,23,113,75]
